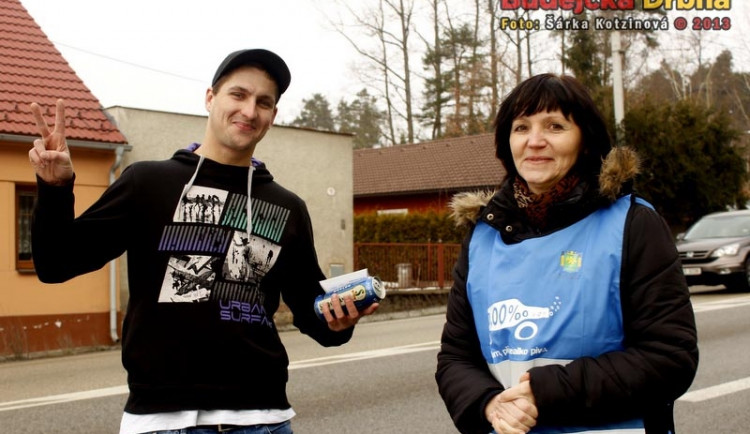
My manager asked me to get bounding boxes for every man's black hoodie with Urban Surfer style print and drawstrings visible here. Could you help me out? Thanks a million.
[32,150,352,414]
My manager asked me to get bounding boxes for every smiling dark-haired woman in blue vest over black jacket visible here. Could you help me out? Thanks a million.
[435,74,698,434]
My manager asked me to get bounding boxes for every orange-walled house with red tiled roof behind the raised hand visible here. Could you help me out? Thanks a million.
[0,0,130,358]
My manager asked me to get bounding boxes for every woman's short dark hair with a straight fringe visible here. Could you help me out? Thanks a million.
[495,74,612,179]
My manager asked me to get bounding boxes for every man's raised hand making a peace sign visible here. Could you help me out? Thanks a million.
[29,99,73,185]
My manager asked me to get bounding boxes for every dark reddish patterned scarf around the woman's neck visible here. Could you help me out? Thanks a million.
[513,173,580,229]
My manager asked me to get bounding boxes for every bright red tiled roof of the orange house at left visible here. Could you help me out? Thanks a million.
[0,0,127,143]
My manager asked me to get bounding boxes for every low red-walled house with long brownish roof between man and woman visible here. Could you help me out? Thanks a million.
[353,134,506,215]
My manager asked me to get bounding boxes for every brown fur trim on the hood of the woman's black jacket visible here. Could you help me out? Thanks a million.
[449,146,640,226]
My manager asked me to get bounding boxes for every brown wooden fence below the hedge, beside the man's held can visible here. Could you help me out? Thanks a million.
[354,243,461,289]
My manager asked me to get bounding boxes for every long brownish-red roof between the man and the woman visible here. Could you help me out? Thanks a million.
[354,134,505,197]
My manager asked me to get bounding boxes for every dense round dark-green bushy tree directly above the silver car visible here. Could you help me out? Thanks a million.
[623,99,748,229]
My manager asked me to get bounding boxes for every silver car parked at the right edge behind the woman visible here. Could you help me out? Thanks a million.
[677,210,750,292]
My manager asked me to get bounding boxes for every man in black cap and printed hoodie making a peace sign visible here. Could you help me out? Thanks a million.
[29,49,377,434]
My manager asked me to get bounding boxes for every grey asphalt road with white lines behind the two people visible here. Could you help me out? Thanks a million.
[0,290,750,434]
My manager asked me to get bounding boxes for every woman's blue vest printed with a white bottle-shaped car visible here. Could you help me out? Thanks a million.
[466,196,644,433]
